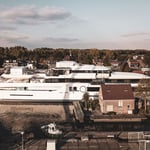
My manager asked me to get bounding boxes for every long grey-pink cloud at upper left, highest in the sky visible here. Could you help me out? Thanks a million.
[0,6,71,24]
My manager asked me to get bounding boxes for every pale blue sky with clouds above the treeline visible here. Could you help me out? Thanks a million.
[0,0,150,50]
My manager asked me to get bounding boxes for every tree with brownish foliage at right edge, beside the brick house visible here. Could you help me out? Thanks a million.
[135,79,150,113]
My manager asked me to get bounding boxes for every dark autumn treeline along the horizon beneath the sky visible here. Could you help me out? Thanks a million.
[0,46,150,66]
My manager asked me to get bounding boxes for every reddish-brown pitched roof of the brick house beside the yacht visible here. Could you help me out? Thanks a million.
[101,84,134,100]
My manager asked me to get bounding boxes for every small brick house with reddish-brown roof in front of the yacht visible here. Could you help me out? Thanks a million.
[99,84,134,114]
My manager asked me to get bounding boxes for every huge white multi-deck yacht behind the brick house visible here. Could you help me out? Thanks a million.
[0,61,150,102]
